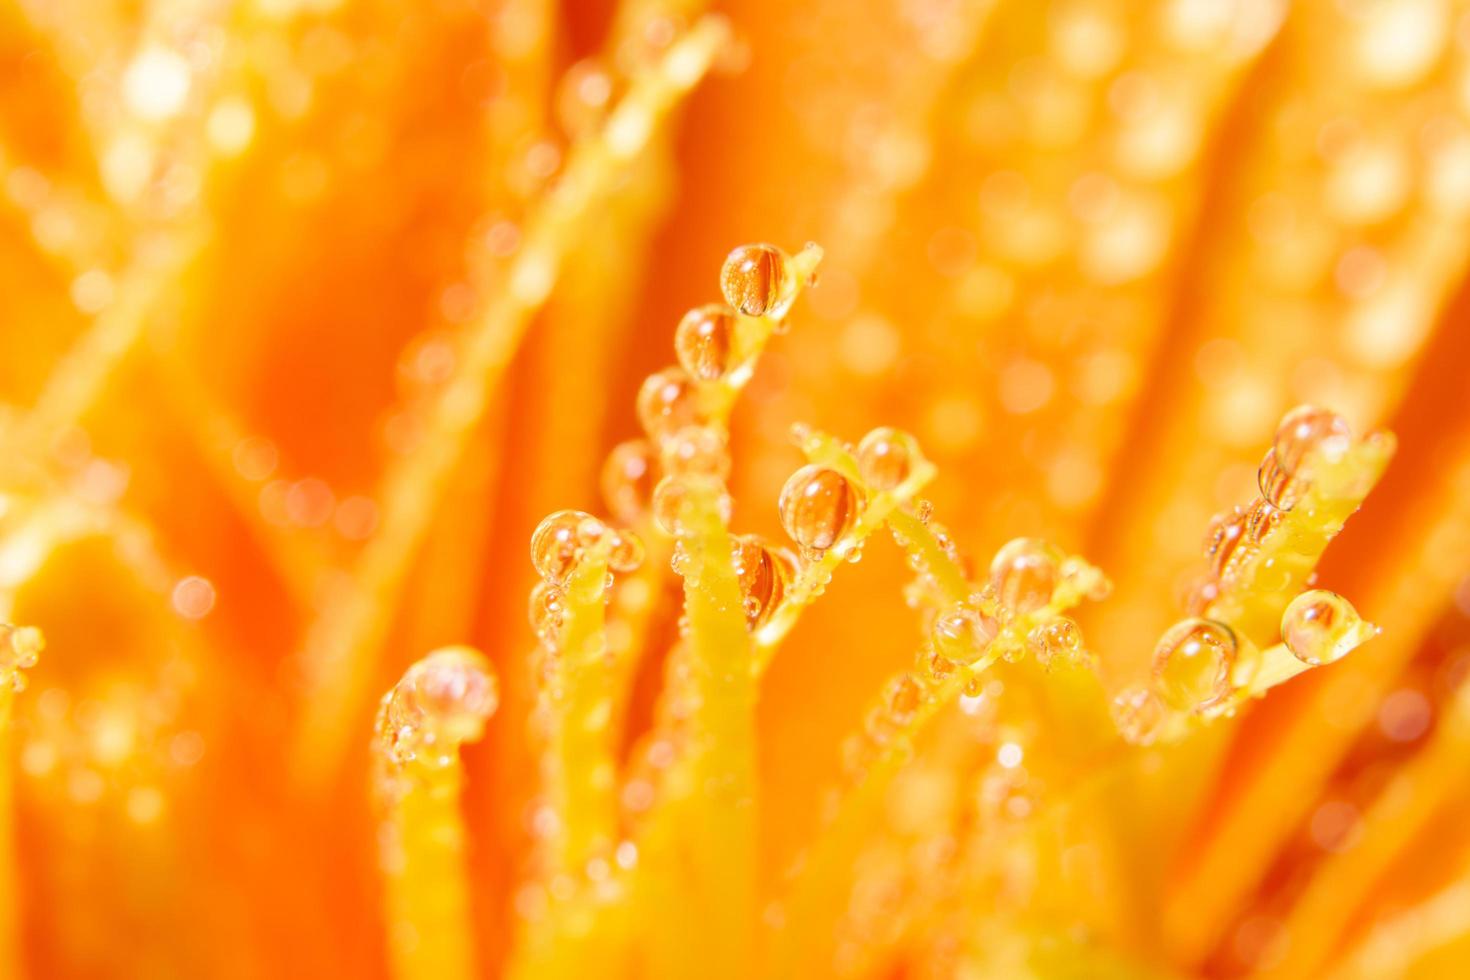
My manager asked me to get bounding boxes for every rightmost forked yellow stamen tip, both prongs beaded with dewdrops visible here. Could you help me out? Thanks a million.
[1113,406,1394,743]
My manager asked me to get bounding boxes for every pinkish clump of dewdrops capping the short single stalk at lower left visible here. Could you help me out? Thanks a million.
[378,646,500,765]
